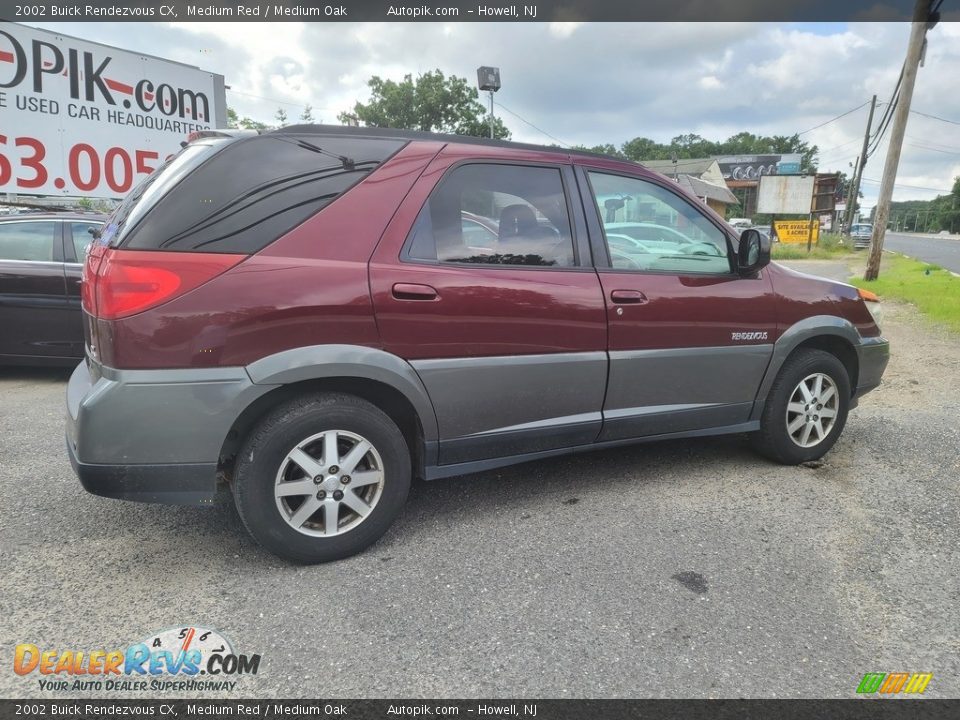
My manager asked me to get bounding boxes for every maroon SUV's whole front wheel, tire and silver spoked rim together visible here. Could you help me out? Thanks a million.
[751,349,850,465]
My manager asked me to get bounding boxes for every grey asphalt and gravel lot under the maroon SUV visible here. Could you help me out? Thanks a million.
[0,268,960,698]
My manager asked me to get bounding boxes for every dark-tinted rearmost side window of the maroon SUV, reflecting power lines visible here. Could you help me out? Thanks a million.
[118,133,405,254]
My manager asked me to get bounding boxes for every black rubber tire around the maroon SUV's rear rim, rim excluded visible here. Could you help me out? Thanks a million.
[233,393,411,564]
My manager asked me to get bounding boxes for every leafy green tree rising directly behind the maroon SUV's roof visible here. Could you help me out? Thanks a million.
[338,70,510,139]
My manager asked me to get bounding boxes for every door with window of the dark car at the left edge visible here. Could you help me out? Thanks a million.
[0,218,79,360]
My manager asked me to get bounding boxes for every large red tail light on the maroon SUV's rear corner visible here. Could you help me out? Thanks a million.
[81,248,246,320]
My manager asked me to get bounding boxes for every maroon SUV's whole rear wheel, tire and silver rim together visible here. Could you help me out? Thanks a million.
[233,393,410,563]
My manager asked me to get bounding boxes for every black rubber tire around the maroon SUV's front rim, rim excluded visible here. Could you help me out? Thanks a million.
[750,349,850,465]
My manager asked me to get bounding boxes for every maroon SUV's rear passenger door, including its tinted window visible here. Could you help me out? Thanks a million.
[370,149,607,464]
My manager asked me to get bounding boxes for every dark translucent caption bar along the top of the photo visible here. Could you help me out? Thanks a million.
[0,0,913,23]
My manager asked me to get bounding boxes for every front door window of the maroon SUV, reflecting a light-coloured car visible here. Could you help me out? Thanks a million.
[588,172,731,274]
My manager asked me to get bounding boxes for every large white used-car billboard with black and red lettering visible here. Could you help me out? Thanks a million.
[0,23,226,198]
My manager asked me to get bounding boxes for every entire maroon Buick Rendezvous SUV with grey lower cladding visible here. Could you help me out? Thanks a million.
[67,126,889,562]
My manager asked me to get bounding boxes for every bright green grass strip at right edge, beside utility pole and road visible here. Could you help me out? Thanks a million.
[850,253,960,332]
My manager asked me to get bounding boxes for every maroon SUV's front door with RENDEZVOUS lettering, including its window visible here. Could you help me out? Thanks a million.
[578,168,776,440]
